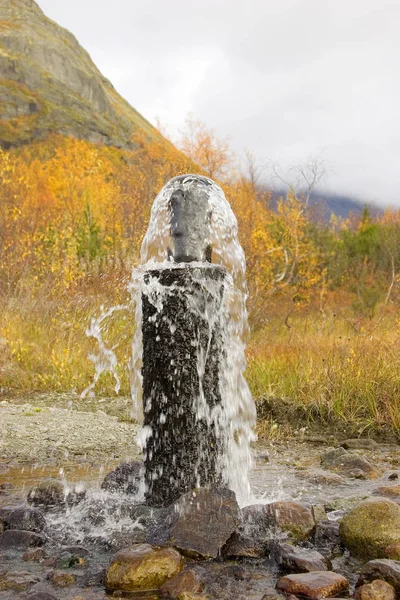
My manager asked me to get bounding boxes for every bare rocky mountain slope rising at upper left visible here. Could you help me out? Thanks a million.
[0,0,164,148]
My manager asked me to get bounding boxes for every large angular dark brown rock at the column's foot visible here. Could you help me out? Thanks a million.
[146,488,240,558]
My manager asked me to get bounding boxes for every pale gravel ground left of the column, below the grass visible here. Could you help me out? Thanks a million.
[0,400,139,464]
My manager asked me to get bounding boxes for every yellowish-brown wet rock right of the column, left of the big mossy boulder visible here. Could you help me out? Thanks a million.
[265,501,315,541]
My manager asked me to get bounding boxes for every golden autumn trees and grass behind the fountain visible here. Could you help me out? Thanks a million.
[0,121,400,434]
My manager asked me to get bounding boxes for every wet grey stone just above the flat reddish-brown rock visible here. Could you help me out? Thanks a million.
[276,543,332,573]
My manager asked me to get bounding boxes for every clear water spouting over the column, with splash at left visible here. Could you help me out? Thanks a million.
[86,175,256,505]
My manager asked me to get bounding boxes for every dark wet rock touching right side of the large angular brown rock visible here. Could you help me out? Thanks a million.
[221,504,277,558]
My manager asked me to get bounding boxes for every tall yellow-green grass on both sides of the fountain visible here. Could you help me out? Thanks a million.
[0,285,400,439]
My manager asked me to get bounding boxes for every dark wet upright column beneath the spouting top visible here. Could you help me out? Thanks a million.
[142,263,225,506]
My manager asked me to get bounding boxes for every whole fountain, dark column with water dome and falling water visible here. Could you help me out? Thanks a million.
[140,175,255,506]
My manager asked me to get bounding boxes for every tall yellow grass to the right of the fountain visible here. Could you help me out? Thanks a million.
[247,315,400,436]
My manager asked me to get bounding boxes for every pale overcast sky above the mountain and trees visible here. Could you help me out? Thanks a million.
[37,0,400,205]
